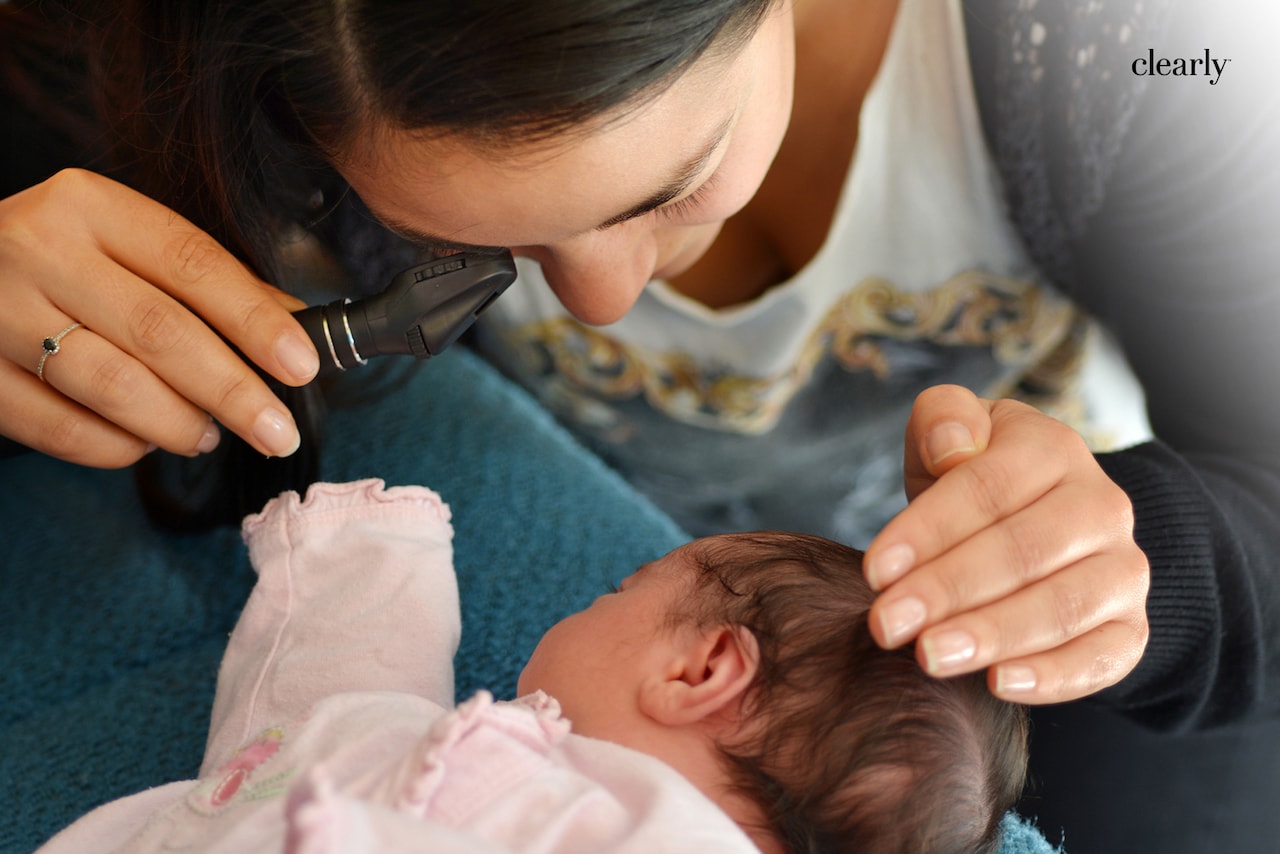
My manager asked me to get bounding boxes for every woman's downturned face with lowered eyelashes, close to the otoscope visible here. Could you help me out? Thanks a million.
[339,1,795,324]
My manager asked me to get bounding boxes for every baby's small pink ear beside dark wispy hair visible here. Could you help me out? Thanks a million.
[640,626,760,726]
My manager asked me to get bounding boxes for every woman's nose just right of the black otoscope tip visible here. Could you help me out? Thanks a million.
[513,224,658,325]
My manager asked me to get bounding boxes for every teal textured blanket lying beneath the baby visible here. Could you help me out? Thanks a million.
[0,351,1052,854]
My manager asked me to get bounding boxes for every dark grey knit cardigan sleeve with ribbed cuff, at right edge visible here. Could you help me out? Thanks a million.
[970,1,1280,730]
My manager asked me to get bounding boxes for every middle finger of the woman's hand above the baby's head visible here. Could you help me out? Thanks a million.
[872,484,1137,647]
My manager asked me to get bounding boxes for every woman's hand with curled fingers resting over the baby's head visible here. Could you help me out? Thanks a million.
[864,385,1149,703]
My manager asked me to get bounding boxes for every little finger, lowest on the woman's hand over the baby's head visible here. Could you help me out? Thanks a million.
[987,621,1149,705]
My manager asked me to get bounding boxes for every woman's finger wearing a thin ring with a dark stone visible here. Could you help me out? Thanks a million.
[30,316,219,457]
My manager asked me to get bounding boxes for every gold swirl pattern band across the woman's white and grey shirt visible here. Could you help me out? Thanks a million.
[513,271,1084,434]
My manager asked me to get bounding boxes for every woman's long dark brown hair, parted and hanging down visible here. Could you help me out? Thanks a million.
[0,0,777,524]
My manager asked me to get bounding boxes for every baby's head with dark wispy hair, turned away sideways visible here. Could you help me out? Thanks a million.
[520,533,1027,853]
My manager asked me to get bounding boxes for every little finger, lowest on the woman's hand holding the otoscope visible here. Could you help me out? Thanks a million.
[0,361,148,469]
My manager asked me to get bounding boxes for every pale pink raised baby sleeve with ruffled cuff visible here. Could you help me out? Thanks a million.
[201,479,461,775]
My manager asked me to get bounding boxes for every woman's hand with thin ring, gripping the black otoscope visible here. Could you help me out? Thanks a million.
[0,169,319,467]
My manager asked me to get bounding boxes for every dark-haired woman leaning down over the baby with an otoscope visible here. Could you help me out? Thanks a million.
[0,0,1280,850]
